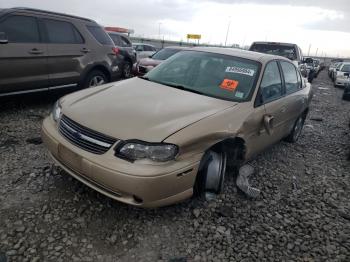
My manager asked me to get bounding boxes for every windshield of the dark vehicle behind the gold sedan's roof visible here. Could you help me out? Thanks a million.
[250,44,297,60]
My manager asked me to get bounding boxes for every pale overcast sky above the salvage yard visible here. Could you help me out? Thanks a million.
[0,0,350,57]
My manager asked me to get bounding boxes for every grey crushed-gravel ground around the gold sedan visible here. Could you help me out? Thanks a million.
[0,72,350,262]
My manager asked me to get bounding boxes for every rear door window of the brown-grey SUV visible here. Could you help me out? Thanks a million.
[44,19,84,44]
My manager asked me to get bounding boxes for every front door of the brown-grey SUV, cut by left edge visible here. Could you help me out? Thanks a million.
[0,13,48,93]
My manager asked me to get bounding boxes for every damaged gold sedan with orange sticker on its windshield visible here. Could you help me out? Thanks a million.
[42,48,312,207]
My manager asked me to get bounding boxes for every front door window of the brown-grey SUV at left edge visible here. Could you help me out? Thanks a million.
[0,15,40,43]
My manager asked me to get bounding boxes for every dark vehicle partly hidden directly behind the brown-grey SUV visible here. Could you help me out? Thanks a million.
[106,29,136,78]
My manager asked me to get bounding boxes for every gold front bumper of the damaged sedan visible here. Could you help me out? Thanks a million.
[42,117,201,208]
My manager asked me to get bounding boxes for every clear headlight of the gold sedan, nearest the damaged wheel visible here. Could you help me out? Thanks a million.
[116,141,178,162]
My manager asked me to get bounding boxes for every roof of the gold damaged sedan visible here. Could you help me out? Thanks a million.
[192,47,291,63]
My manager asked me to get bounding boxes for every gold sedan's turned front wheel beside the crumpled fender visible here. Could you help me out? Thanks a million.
[194,150,227,198]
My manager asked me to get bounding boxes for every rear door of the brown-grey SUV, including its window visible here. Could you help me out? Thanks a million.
[41,18,87,86]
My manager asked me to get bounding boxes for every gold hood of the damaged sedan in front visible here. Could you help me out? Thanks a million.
[61,78,237,142]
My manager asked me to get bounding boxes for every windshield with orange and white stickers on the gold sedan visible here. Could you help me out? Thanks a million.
[145,51,260,102]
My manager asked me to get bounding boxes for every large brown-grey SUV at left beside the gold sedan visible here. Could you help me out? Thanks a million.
[0,8,122,96]
